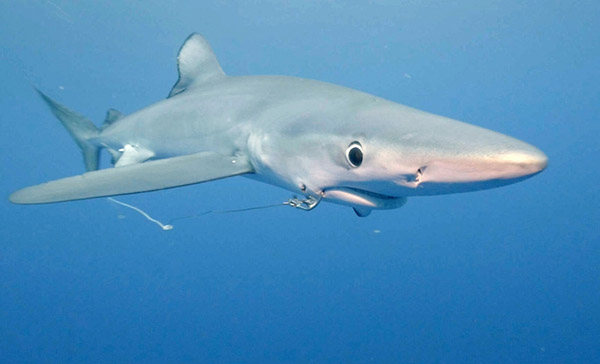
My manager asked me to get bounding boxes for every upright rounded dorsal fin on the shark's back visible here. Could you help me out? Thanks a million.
[169,33,225,97]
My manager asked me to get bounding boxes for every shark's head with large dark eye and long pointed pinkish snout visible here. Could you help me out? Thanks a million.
[246,79,547,209]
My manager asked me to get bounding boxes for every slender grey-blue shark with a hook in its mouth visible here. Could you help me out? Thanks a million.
[9,33,548,217]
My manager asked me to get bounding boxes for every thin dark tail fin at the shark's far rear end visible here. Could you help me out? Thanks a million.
[36,89,100,171]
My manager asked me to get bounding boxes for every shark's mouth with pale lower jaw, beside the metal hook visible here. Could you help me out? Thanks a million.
[322,187,406,209]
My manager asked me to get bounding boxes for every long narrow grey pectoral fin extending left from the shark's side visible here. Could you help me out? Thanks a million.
[10,152,254,204]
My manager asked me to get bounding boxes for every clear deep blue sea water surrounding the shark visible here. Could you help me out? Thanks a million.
[0,0,600,363]
